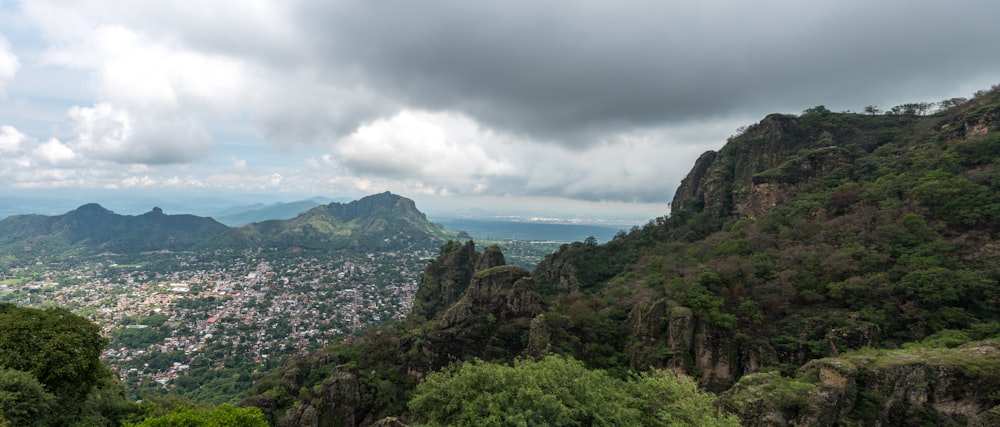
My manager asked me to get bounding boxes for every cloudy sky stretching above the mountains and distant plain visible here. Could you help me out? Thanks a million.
[0,0,1000,223]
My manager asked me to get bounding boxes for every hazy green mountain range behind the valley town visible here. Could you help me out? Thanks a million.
[0,192,454,264]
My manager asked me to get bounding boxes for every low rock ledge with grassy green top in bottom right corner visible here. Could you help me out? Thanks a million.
[723,341,1000,426]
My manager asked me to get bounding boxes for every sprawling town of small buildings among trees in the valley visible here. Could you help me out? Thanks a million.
[0,249,436,403]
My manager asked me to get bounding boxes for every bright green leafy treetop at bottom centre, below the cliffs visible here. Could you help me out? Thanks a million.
[409,356,738,426]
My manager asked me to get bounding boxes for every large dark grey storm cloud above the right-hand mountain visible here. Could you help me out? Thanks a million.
[299,1,1000,144]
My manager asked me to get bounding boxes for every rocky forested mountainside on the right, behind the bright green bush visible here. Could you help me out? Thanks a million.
[244,88,1000,426]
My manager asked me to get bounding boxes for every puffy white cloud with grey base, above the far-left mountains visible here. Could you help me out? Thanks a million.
[69,102,212,164]
